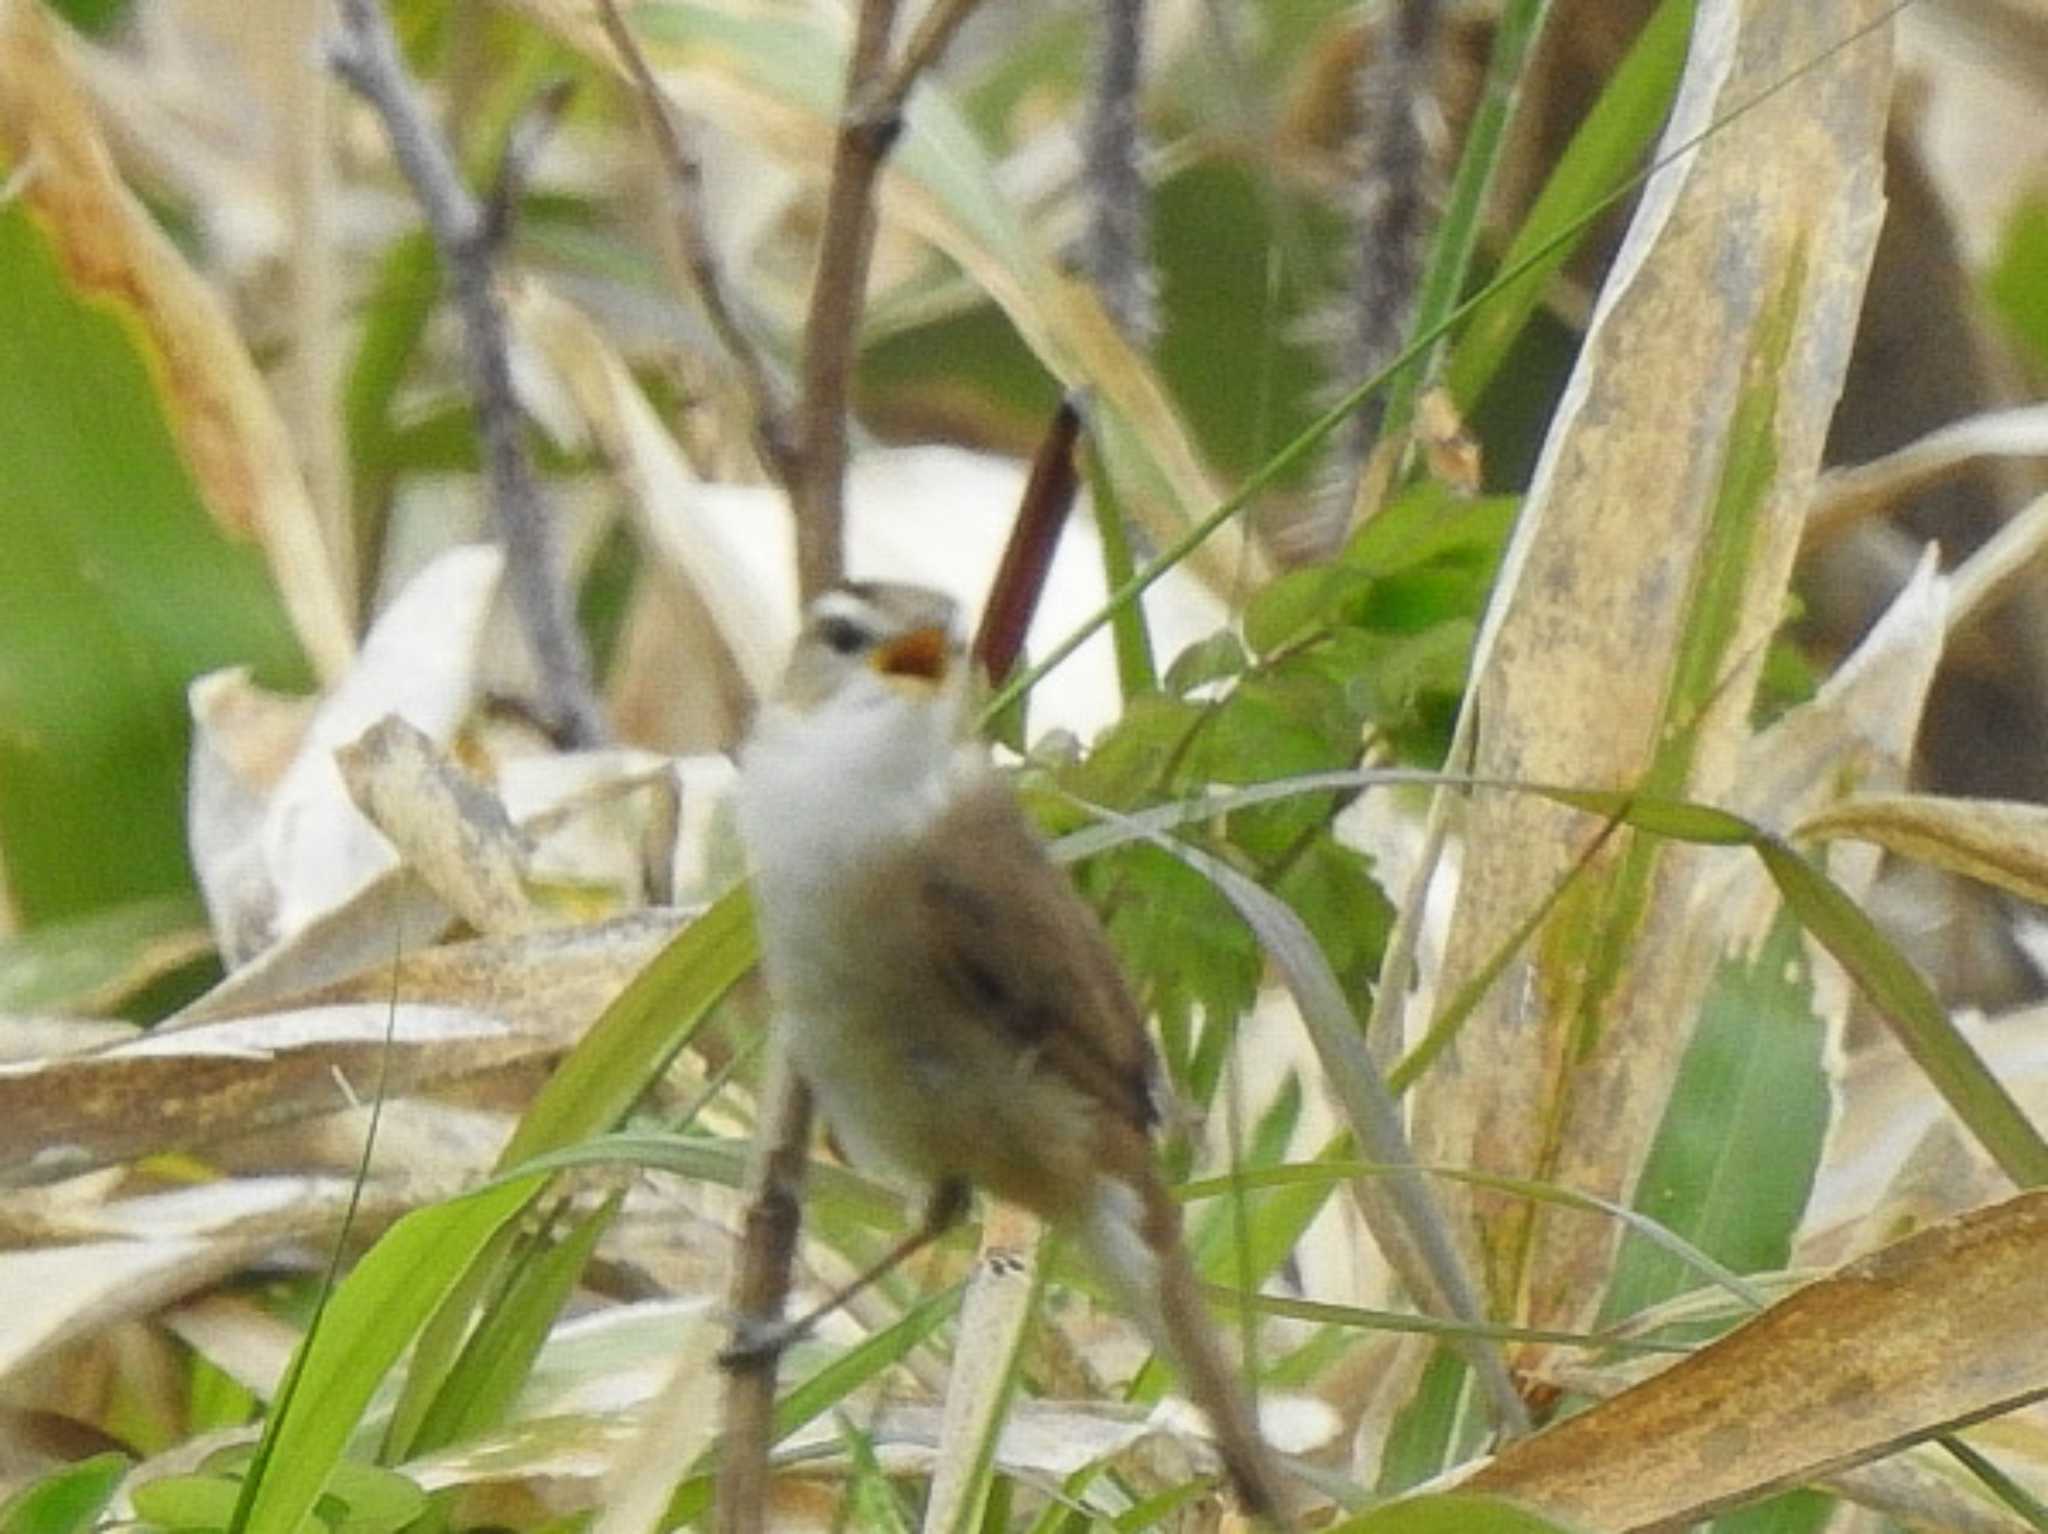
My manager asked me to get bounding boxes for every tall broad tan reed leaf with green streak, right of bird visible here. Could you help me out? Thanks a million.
[1415,0,1890,1327]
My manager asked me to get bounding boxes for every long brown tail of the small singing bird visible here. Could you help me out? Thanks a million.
[1079,1167,1286,1526]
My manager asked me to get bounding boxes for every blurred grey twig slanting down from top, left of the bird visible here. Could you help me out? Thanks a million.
[328,0,606,745]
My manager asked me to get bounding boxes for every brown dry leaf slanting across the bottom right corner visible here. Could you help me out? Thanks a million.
[1464,1192,2048,1530]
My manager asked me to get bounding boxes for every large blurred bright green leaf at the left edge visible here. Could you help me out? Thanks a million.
[0,190,307,926]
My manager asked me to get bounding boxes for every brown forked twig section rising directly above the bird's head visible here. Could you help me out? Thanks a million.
[791,0,991,600]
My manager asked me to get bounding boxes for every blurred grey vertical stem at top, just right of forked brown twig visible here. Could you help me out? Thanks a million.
[1081,0,1159,346]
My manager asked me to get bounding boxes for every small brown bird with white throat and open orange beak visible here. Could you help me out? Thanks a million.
[739,582,1280,1518]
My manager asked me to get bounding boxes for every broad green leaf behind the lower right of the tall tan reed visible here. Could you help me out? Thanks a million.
[1602,913,1829,1323]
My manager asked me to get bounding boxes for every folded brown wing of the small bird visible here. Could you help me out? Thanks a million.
[915,778,1159,1131]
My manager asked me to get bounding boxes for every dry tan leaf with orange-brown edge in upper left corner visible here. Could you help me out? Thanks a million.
[0,0,354,678]
